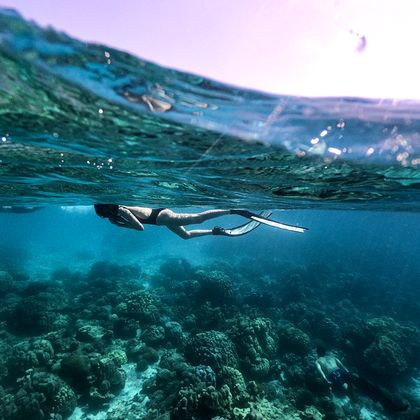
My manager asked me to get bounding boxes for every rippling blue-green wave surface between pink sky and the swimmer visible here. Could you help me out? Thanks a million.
[0,10,420,211]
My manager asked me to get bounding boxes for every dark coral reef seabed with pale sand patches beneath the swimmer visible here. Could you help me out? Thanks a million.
[0,258,420,420]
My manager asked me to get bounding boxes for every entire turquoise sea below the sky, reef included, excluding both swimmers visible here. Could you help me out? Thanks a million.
[0,10,420,419]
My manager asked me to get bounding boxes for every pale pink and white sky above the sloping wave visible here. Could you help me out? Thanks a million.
[0,0,420,99]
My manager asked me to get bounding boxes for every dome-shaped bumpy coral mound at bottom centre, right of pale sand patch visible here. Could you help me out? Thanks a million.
[185,330,238,373]
